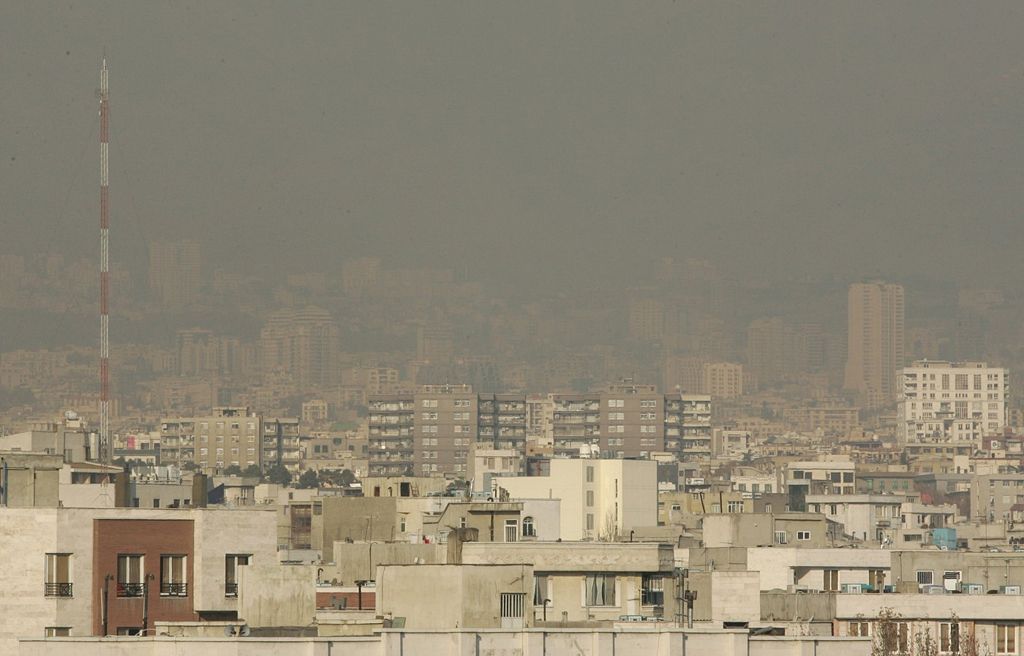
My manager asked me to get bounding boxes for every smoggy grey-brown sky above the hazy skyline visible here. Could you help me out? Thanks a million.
[0,0,1024,286]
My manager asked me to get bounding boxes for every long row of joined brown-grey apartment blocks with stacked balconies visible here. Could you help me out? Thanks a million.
[368,384,712,476]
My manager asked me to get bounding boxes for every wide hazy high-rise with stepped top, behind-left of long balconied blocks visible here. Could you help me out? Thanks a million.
[259,306,340,388]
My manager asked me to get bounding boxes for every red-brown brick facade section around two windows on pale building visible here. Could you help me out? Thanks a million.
[92,519,196,636]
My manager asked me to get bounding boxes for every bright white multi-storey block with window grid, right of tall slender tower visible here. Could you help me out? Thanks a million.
[899,360,1009,442]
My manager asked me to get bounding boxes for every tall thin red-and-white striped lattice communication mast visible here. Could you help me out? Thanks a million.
[99,58,114,463]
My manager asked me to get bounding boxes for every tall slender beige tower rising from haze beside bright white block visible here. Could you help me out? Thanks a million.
[845,282,903,406]
